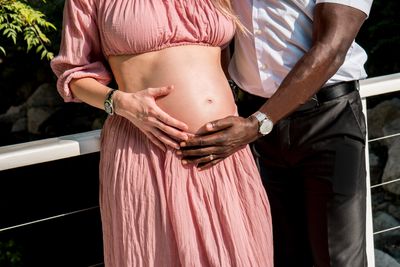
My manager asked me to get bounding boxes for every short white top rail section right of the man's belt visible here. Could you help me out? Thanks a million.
[360,73,400,98]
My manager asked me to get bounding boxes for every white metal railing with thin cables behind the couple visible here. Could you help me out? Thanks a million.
[0,73,400,267]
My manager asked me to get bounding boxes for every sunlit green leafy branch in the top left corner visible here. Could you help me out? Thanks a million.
[0,0,56,60]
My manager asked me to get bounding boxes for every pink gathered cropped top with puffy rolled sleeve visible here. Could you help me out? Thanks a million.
[51,0,235,102]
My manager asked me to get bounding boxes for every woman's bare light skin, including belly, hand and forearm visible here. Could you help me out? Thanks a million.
[70,45,236,151]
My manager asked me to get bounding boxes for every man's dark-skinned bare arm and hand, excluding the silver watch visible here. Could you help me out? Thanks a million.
[177,3,367,169]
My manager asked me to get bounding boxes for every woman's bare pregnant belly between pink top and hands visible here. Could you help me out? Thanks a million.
[110,46,236,133]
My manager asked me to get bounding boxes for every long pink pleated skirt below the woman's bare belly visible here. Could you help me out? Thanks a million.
[100,115,273,267]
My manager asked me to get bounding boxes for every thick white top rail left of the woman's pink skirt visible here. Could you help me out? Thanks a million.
[0,130,100,171]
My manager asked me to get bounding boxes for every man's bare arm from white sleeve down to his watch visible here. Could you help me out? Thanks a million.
[260,3,366,123]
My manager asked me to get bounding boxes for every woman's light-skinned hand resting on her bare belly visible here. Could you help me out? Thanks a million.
[113,86,188,151]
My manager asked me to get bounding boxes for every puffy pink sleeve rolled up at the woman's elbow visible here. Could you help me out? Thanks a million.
[50,0,112,102]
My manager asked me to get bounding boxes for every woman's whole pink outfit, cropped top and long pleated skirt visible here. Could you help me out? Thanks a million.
[51,0,273,267]
